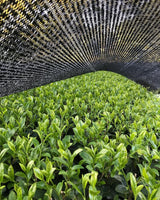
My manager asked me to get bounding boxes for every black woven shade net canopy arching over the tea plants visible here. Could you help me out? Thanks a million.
[0,0,160,96]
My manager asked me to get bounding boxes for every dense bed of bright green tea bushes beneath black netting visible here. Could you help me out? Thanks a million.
[0,72,160,200]
